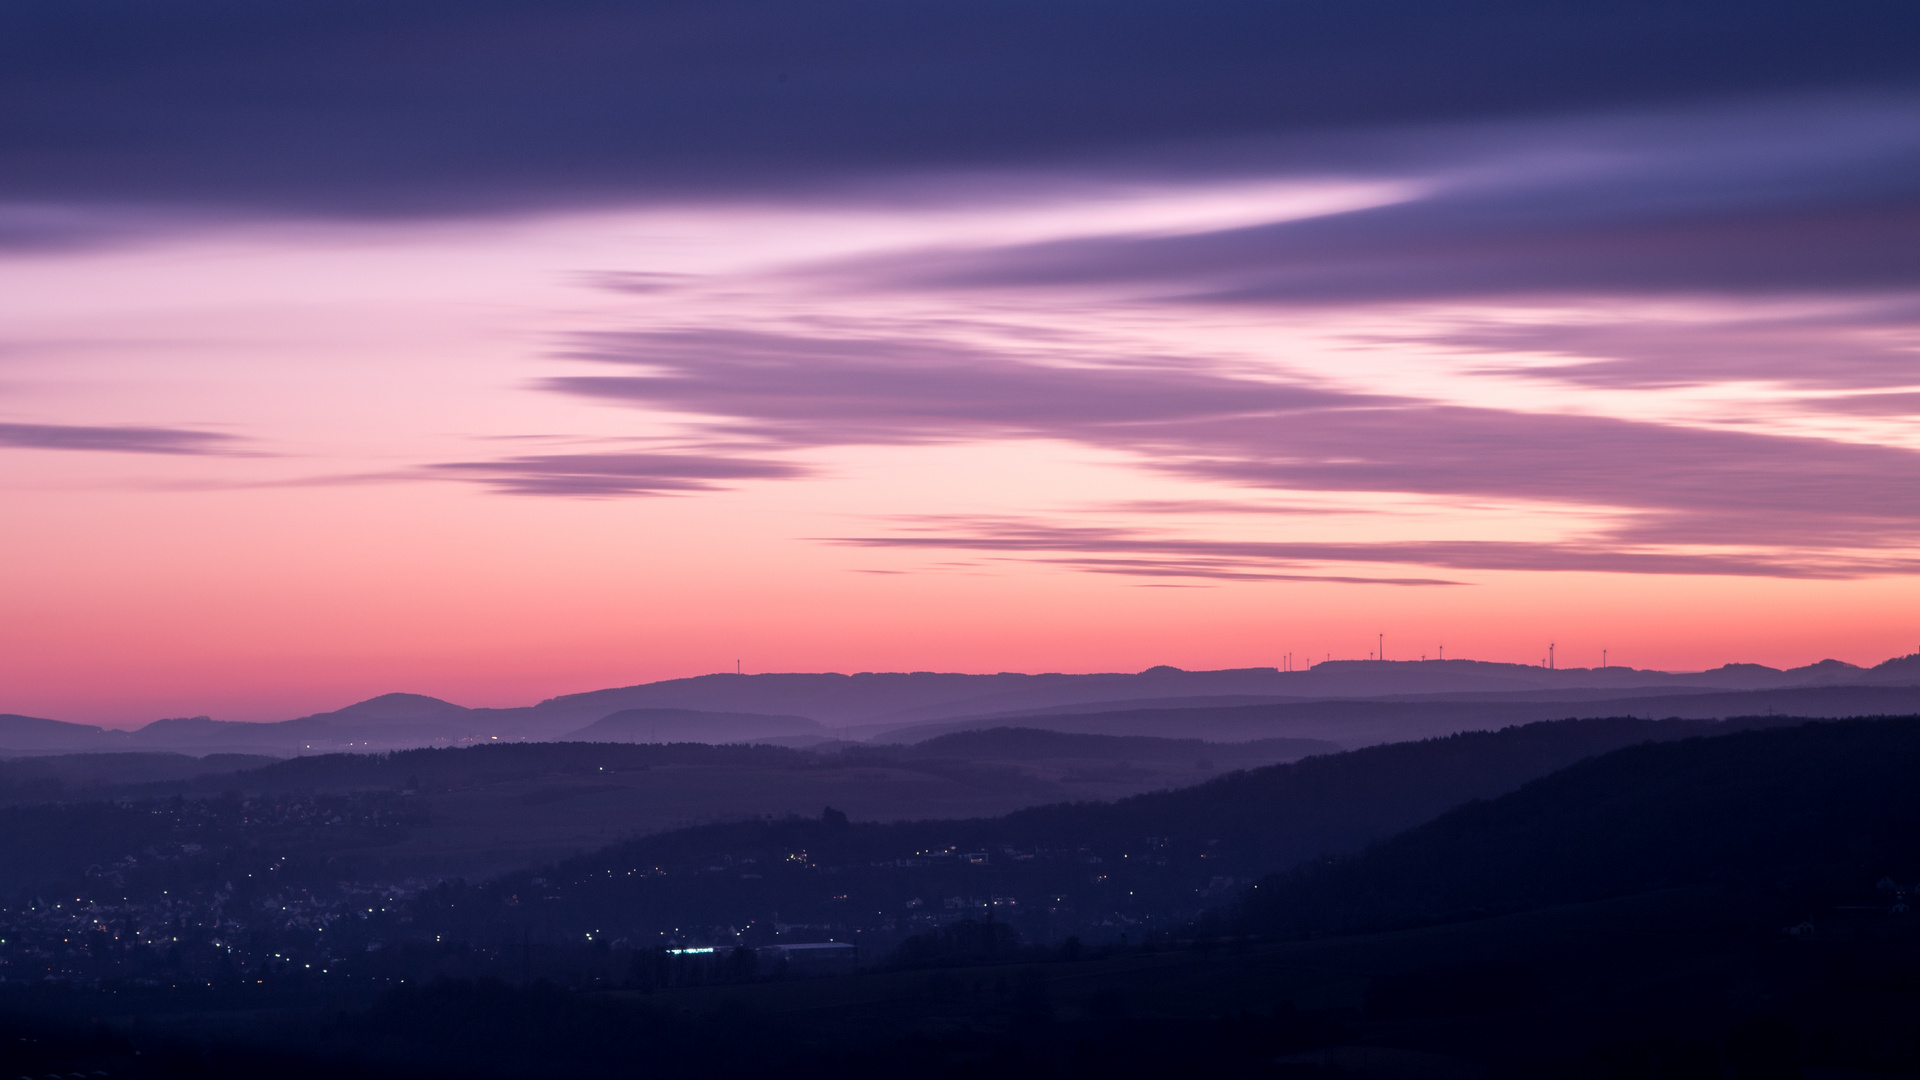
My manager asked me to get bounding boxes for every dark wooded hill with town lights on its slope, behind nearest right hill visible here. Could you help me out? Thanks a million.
[441,719,1804,938]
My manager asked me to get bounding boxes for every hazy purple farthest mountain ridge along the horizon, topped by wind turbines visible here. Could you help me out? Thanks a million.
[0,653,1920,755]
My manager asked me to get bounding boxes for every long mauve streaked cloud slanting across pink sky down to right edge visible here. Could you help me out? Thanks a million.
[549,322,1920,577]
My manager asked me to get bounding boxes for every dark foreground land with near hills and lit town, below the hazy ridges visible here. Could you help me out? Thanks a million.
[0,719,1920,1078]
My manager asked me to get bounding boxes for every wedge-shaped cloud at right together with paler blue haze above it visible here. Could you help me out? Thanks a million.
[802,100,1920,319]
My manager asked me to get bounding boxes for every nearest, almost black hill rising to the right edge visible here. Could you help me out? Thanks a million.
[1244,717,1920,934]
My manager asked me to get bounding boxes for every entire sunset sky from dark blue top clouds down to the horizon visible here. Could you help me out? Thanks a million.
[0,0,1920,726]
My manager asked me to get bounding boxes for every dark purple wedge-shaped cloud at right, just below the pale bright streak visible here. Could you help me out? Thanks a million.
[835,175,1920,304]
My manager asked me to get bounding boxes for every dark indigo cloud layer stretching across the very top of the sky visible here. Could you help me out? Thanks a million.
[0,0,1920,215]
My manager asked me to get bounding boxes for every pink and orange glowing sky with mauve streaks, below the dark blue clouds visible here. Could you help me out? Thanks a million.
[0,105,1920,724]
